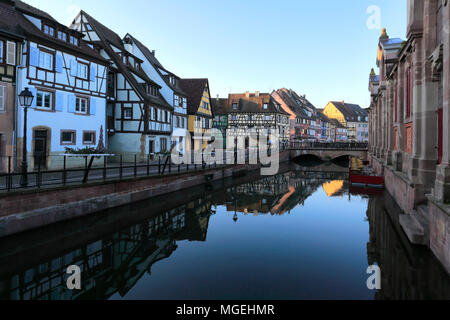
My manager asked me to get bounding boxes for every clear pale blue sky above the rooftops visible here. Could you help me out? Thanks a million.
[25,0,406,108]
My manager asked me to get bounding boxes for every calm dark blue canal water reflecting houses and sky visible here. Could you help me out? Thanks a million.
[0,165,450,300]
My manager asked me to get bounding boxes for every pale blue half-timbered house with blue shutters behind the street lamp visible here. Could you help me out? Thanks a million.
[13,1,108,169]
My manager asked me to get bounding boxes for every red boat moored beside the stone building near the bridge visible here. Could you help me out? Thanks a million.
[349,157,384,189]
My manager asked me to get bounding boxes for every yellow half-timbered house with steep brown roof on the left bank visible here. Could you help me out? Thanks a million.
[180,79,213,150]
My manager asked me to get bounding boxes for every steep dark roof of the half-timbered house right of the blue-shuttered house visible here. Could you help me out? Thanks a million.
[76,11,173,110]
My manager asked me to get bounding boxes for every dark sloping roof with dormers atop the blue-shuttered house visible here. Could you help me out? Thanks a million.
[0,0,109,65]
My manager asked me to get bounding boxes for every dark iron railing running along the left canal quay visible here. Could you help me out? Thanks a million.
[0,155,223,192]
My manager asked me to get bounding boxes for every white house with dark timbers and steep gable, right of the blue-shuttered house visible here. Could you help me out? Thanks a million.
[71,11,173,160]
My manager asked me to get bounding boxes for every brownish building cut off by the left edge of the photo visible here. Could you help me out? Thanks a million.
[0,1,23,173]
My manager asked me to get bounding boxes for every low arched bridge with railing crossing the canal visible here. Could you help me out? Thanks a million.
[290,142,368,160]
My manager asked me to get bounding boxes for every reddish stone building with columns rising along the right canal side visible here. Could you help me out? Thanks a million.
[369,0,450,272]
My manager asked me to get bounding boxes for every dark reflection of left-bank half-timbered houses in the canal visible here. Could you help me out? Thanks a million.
[0,196,213,300]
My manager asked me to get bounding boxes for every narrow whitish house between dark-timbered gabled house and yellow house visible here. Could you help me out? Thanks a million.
[124,34,188,153]
